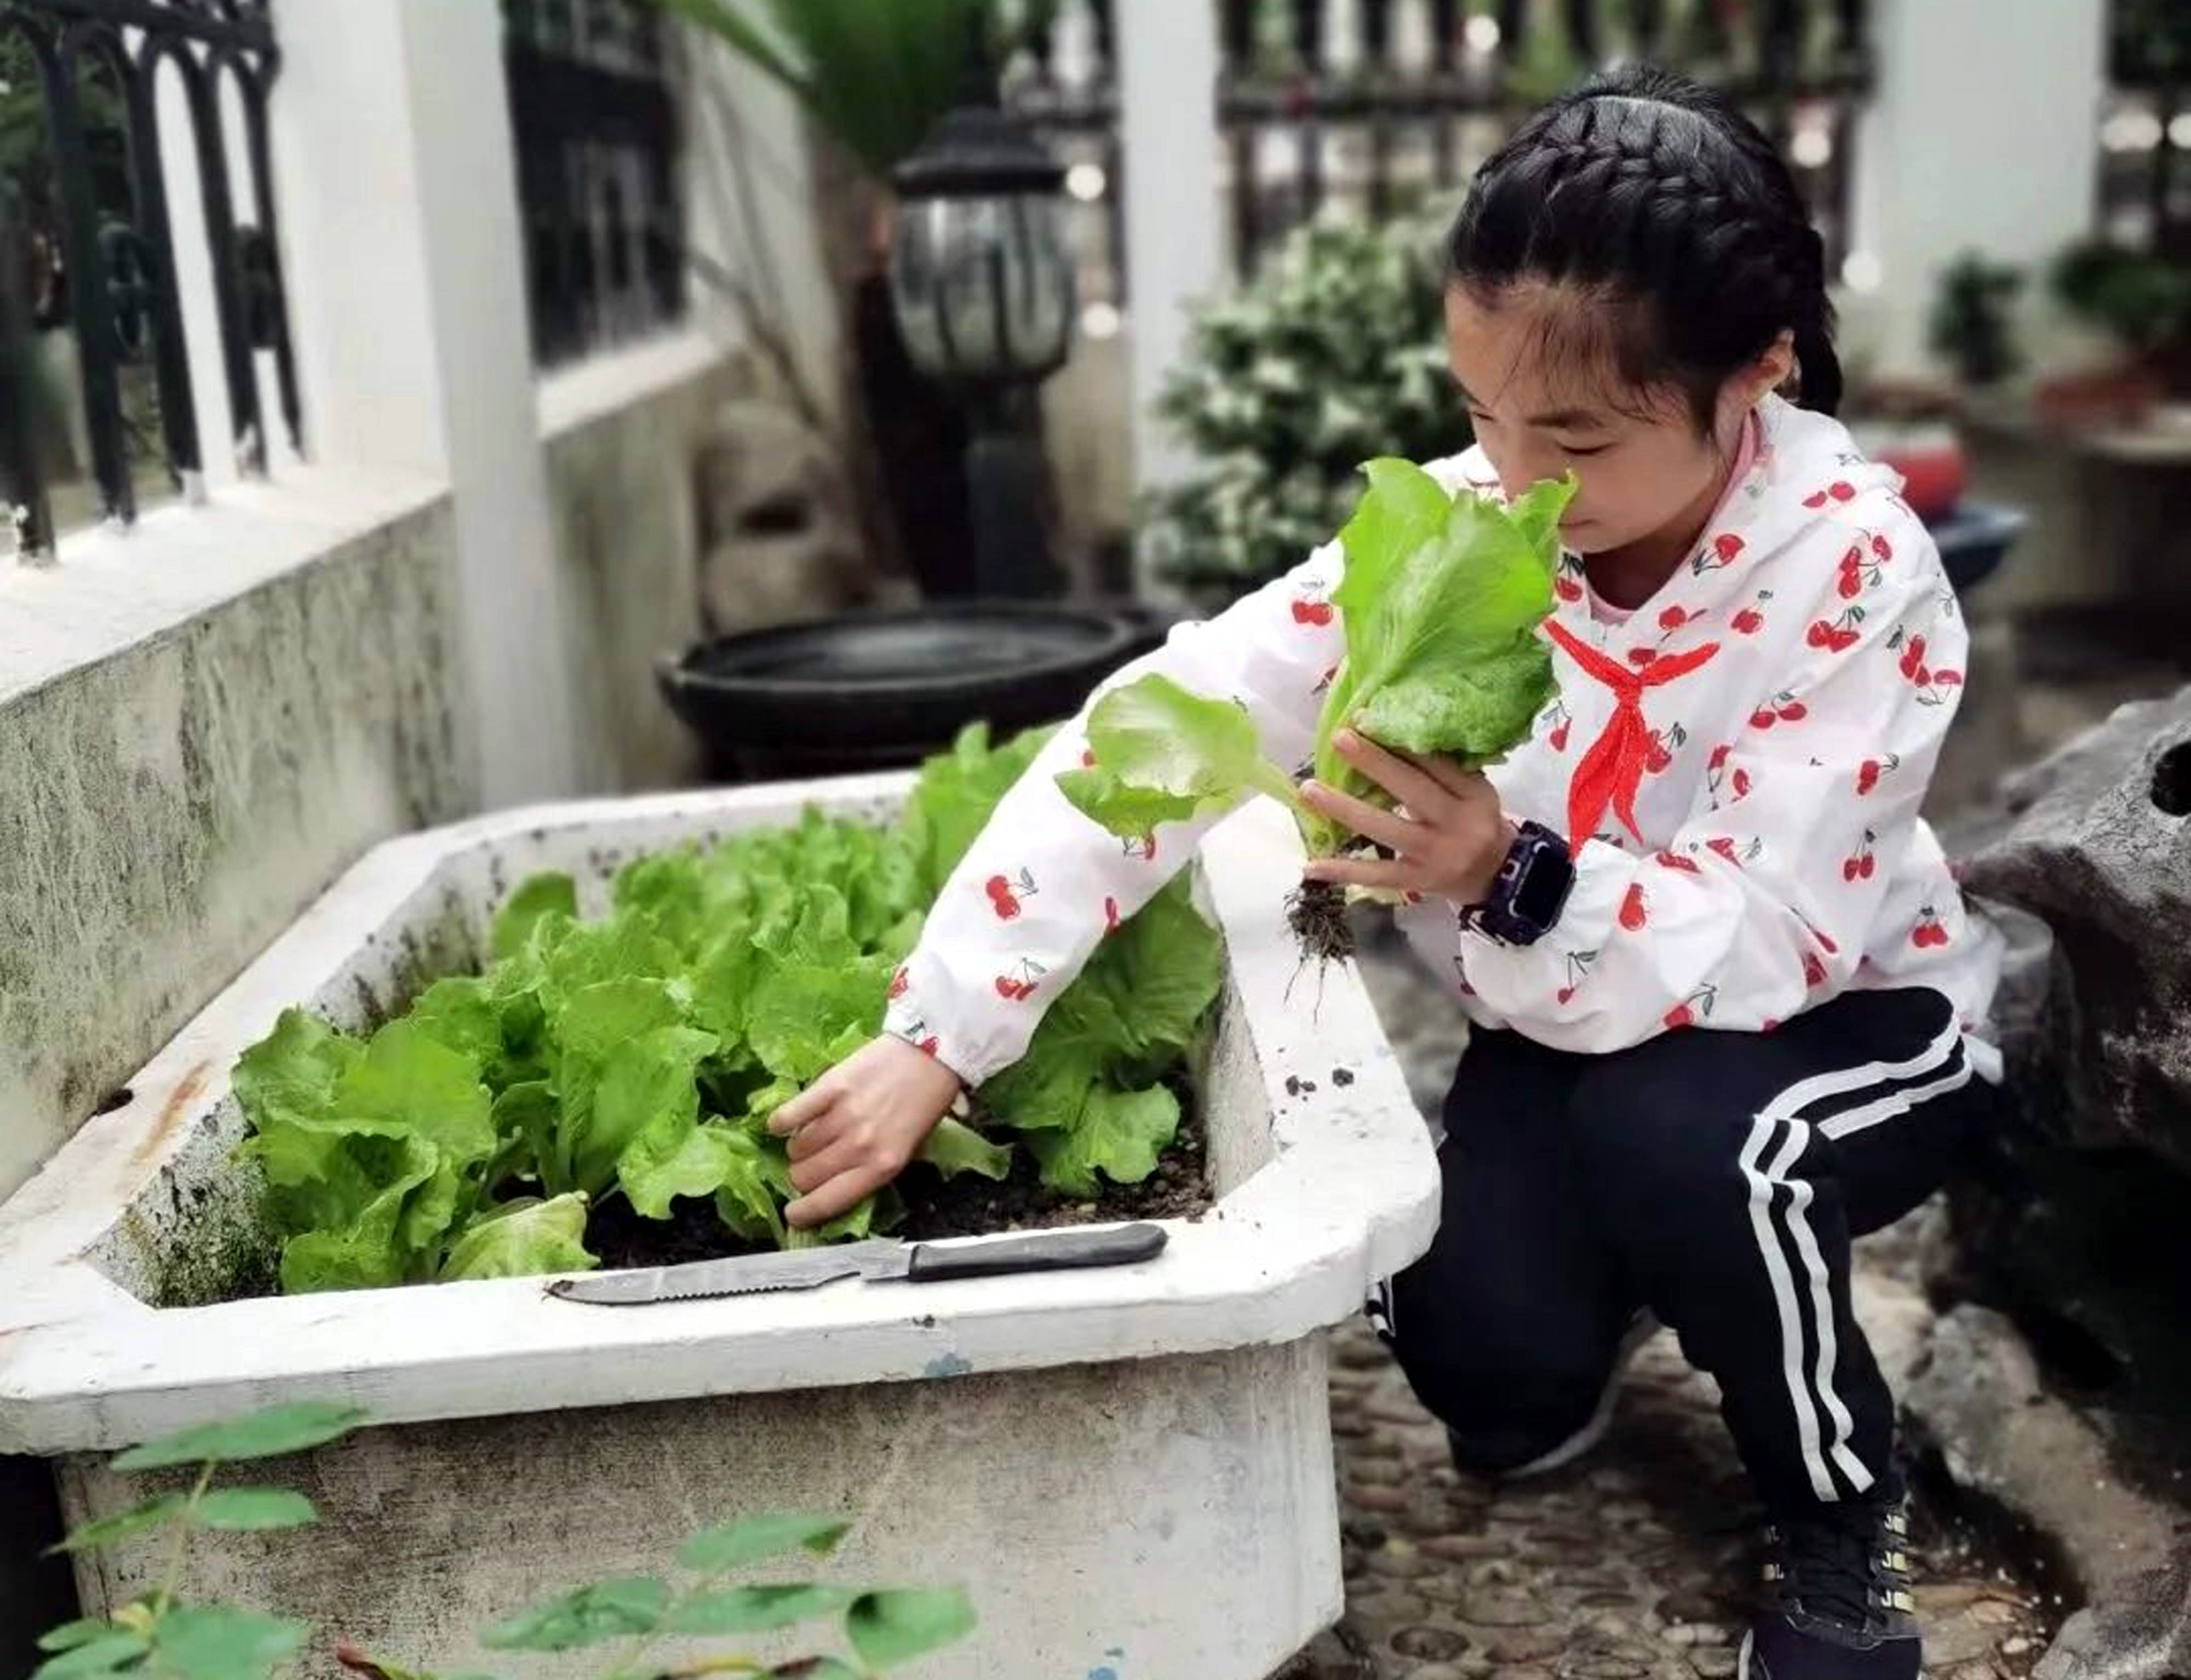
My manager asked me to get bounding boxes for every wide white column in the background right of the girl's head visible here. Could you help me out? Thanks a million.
[1847,0,2108,375]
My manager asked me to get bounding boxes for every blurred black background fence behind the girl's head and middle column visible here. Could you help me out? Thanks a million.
[1012,0,1873,319]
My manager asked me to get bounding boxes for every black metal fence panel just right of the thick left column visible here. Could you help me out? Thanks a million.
[502,0,686,366]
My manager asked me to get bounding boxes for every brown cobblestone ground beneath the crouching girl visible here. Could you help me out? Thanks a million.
[1286,928,2044,1680]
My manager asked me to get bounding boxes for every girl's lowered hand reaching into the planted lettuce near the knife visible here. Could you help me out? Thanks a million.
[769,1031,960,1226]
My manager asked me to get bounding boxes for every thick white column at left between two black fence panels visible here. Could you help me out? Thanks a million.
[274,0,581,806]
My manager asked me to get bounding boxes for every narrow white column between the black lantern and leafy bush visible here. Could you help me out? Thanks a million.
[1115,0,1225,499]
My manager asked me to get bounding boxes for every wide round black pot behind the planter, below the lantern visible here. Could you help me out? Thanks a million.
[659,600,1170,782]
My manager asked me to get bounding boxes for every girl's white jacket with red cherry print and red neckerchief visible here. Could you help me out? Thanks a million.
[883,399,2000,1084]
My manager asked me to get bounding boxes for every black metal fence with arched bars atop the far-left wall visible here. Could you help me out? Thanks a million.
[0,0,302,557]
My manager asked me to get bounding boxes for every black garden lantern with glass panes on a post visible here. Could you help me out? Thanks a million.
[890,91,1074,596]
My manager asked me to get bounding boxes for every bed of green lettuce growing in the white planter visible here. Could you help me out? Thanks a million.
[234,727,1223,1292]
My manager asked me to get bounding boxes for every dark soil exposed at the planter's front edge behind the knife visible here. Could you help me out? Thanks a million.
[585,1095,1209,1270]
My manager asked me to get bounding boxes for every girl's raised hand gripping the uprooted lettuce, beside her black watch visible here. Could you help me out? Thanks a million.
[1301,730,1514,904]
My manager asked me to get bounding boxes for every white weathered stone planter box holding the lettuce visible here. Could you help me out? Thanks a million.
[0,776,1437,1680]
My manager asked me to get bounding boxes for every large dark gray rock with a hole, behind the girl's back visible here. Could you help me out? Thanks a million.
[1965,690,2191,1167]
